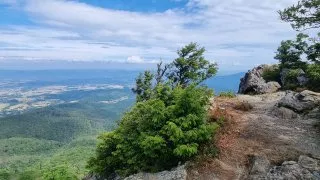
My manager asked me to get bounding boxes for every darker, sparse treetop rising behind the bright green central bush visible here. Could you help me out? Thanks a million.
[132,43,217,102]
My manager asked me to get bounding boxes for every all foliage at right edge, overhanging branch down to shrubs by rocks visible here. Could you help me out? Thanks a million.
[275,0,320,91]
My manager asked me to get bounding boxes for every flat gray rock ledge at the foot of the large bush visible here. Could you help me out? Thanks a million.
[125,165,187,180]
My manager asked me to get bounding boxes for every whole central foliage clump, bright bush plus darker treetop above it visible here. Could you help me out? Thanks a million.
[88,43,219,177]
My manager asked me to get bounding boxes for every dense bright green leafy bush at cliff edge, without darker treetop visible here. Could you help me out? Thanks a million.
[88,86,219,176]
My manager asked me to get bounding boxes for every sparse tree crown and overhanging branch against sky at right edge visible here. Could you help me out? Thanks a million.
[275,0,320,70]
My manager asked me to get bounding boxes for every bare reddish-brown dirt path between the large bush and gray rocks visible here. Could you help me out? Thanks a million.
[188,92,320,180]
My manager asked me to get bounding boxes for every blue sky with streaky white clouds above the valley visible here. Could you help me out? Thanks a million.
[0,0,296,70]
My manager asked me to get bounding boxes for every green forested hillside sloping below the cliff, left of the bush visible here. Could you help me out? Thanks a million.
[0,89,134,179]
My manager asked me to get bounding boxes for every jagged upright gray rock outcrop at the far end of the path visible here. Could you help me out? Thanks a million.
[238,65,281,94]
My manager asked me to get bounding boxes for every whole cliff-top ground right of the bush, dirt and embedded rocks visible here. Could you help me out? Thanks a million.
[187,91,320,179]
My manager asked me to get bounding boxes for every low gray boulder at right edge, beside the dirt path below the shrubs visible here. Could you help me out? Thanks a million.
[278,90,320,112]
